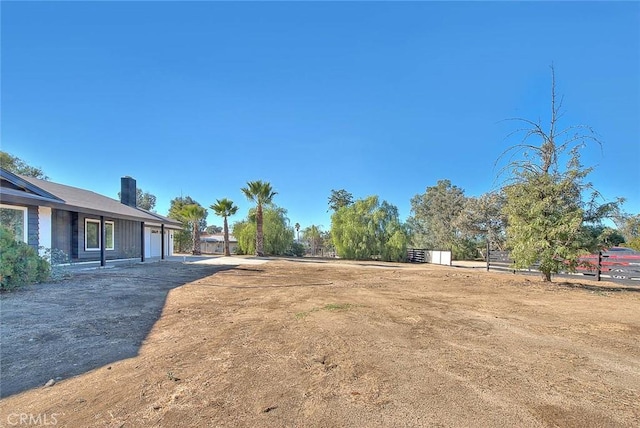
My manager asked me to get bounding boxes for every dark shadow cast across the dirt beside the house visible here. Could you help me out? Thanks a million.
[0,261,234,398]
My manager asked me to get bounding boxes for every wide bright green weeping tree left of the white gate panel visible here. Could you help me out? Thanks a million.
[331,196,408,261]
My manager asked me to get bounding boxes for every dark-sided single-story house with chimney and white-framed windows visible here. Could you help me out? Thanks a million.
[0,167,182,266]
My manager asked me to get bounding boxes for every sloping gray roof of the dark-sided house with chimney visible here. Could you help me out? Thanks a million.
[0,169,182,229]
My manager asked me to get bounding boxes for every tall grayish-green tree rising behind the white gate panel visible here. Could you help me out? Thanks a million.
[408,180,467,259]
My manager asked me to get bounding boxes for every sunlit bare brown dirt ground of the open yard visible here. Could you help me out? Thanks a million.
[0,259,640,427]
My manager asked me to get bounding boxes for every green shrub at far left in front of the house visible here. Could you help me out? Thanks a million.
[0,227,50,290]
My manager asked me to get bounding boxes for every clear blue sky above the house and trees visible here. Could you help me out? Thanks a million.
[0,1,640,230]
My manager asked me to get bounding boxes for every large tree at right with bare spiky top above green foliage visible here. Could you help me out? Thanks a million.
[501,67,620,281]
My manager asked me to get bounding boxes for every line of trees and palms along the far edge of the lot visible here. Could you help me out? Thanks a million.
[0,67,640,281]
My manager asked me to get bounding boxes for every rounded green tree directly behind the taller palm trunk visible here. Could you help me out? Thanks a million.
[233,204,294,256]
